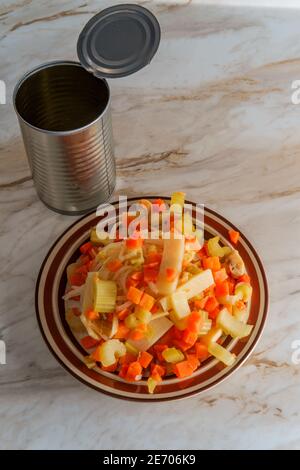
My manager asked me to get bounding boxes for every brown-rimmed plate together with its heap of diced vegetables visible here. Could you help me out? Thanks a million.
[36,192,268,401]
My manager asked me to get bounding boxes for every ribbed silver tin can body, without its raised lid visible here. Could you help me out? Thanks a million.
[14,61,116,215]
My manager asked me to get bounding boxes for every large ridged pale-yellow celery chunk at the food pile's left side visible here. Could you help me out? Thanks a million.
[94,277,117,313]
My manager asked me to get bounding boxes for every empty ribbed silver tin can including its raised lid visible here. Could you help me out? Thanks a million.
[13,4,160,215]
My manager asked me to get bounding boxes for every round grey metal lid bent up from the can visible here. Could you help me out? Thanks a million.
[77,4,160,78]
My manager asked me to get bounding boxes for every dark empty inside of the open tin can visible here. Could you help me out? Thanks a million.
[15,64,109,132]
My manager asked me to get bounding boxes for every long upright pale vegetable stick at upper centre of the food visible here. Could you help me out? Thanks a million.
[156,237,184,295]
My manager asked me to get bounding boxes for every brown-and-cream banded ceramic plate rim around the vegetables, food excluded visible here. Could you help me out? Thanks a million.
[36,196,268,402]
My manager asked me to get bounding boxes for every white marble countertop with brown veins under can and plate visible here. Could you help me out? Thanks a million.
[0,0,300,449]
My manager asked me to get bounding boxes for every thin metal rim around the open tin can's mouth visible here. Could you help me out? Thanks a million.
[13,60,111,136]
